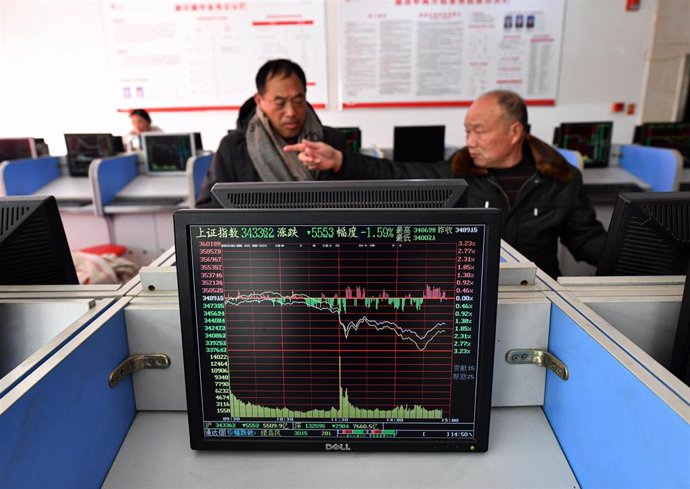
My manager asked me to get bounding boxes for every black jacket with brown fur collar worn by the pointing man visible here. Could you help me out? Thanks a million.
[344,136,606,277]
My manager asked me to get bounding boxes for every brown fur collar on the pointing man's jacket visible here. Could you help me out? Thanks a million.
[451,135,573,183]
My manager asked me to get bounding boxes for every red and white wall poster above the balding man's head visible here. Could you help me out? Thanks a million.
[339,0,565,109]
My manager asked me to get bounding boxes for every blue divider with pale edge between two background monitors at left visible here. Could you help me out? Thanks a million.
[89,154,139,215]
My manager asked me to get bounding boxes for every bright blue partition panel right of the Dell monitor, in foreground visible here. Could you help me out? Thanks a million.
[544,304,690,489]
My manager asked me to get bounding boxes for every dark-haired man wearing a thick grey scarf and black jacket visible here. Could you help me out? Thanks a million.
[197,59,366,207]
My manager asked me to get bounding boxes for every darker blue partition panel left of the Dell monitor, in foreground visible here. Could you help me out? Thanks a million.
[0,311,136,488]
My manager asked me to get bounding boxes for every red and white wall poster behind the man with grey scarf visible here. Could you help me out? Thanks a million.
[102,0,328,111]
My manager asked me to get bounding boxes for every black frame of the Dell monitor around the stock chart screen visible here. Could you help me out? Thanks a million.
[173,209,500,452]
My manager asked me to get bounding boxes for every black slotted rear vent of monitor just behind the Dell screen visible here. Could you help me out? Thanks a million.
[218,188,453,209]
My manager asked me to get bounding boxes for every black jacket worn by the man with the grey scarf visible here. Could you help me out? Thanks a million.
[197,98,354,207]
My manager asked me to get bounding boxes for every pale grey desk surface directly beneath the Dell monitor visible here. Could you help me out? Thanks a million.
[103,407,579,489]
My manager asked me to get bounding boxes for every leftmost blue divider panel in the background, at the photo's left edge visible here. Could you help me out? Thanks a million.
[0,156,60,196]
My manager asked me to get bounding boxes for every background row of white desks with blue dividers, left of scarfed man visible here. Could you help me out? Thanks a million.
[0,153,212,264]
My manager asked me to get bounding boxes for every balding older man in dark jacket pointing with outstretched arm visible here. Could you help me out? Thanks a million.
[285,90,606,277]
